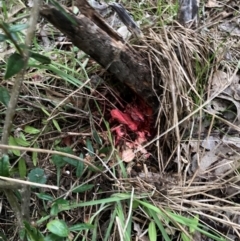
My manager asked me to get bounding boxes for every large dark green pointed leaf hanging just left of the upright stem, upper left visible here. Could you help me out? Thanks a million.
[4,53,25,79]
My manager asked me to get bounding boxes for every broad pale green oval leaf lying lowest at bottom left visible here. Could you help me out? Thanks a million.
[47,220,69,238]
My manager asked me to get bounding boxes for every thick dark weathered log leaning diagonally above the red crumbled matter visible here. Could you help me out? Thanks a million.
[40,0,159,109]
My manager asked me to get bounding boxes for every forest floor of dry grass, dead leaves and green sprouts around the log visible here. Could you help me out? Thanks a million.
[0,0,240,241]
